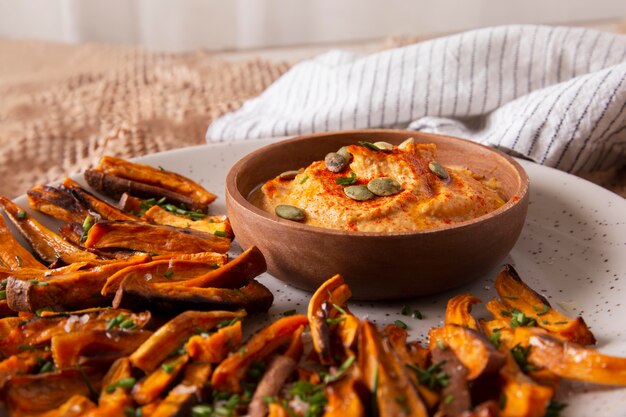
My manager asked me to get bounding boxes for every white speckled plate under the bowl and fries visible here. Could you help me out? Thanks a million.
[9,139,626,417]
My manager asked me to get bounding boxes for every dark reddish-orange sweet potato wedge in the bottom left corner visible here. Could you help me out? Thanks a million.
[5,369,104,416]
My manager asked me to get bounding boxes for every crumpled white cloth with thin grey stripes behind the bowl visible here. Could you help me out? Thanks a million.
[206,25,626,172]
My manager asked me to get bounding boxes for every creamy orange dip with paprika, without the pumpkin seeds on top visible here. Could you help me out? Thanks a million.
[251,143,504,232]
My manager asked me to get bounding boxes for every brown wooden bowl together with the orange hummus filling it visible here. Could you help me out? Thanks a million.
[226,129,529,300]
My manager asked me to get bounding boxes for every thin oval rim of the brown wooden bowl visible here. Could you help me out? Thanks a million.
[225,129,530,238]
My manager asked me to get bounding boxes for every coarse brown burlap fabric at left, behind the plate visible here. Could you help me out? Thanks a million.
[0,39,289,197]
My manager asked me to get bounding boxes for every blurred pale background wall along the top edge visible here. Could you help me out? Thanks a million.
[0,0,626,51]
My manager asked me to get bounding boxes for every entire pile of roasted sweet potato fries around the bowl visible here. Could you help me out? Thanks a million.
[0,154,626,417]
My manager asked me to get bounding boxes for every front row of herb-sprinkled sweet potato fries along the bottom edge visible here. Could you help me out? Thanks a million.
[0,266,626,417]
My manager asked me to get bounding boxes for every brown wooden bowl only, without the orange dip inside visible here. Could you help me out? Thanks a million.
[226,130,528,300]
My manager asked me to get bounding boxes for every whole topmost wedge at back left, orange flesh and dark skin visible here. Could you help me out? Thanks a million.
[85,156,216,211]
